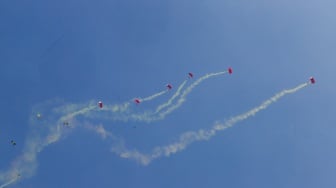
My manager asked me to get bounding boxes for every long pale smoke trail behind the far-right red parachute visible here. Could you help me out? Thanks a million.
[111,83,308,165]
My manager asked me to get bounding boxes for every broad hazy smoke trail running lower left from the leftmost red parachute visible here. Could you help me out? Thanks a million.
[0,102,96,186]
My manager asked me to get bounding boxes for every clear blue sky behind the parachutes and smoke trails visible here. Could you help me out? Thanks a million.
[0,0,336,188]
